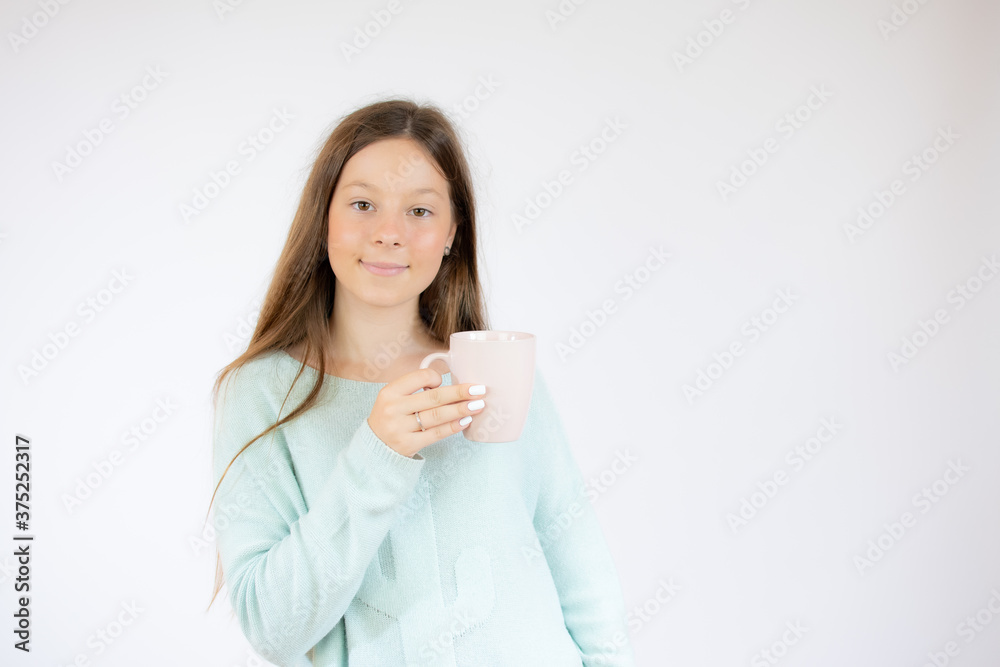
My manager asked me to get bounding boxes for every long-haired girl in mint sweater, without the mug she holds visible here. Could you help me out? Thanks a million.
[210,100,633,667]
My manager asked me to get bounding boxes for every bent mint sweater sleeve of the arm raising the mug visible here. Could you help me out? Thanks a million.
[213,361,424,666]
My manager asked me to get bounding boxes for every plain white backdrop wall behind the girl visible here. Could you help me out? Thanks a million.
[0,0,1000,667]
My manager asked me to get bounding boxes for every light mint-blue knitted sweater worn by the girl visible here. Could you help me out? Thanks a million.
[213,352,634,667]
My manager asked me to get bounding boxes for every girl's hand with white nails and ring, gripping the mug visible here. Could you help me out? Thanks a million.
[368,368,486,458]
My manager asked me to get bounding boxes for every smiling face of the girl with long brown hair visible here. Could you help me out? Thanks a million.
[327,138,457,314]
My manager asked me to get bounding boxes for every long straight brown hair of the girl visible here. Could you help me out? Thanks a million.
[206,99,488,608]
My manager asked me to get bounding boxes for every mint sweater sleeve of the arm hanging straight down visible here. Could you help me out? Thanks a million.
[532,370,635,667]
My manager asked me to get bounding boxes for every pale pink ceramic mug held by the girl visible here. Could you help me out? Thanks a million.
[420,331,535,442]
